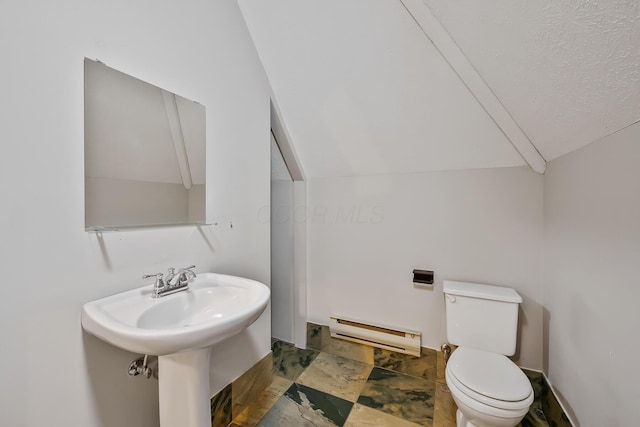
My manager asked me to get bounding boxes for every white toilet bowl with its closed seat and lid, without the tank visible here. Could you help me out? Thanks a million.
[445,347,533,427]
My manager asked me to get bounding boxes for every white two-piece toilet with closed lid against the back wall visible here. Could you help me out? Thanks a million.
[444,280,533,427]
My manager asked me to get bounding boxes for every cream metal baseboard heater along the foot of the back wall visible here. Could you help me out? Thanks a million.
[329,316,421,356]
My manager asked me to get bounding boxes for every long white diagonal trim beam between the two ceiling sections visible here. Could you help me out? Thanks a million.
[399,0,547,174]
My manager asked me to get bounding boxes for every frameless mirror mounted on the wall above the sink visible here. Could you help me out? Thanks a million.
[84,59,206,231]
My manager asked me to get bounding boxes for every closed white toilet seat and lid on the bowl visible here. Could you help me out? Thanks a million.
[446,347,534,416]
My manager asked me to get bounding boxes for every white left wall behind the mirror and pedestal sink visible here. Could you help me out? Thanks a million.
[0,0,270,427]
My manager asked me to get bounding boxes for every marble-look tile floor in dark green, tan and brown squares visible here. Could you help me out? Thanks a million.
[229,340,550,427]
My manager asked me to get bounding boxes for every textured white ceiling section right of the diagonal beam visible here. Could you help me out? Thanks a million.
[425,0,640,160]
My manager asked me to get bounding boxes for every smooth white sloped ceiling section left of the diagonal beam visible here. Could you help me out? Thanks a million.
[240,0,524,178]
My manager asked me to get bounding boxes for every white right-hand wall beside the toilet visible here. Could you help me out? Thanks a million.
[544,124,640,427]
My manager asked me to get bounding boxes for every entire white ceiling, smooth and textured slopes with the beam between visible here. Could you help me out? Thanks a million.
[239,0,640,177]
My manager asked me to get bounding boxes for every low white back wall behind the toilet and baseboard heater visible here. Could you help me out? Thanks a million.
[307,167,542,369]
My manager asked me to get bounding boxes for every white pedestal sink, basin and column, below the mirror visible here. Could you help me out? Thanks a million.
[82,273,270,427]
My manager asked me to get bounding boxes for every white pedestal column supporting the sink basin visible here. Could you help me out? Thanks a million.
[158,347,211,427]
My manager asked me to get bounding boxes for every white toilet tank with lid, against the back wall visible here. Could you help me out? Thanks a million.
[443,280,522,356]
